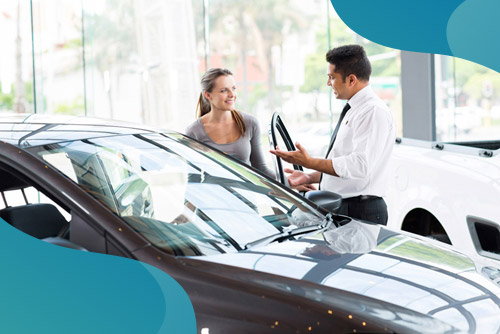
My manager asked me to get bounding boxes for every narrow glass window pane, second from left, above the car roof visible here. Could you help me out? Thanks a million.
[33,0,85,115]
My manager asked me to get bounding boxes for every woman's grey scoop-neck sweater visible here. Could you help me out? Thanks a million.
[185,113,275,178]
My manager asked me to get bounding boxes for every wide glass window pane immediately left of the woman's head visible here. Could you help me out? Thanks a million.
[82,0,198,131]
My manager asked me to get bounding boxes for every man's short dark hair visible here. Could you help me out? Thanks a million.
[326,45,372,82]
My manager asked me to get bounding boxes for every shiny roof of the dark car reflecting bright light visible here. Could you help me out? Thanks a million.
[0,114,169,147]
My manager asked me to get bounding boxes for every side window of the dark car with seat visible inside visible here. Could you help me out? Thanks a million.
[0,168,112,255]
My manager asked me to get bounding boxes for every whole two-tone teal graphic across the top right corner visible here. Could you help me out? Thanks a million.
[331,0,500,71]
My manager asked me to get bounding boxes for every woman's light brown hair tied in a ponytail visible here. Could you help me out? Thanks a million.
[196,68,246,136]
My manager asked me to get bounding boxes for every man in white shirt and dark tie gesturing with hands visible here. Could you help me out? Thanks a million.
[271,45,395,225]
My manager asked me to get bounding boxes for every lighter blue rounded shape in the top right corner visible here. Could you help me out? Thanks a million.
[447,0,500,72]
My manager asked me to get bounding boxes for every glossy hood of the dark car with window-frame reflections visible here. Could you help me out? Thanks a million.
[197,224,500,333]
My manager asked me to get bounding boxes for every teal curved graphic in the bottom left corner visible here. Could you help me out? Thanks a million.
[0,219,196,334]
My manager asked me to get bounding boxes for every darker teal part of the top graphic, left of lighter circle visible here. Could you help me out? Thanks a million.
[331,0,465,55]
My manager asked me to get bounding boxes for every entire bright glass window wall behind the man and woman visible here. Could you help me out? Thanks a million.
[0,0,401,149]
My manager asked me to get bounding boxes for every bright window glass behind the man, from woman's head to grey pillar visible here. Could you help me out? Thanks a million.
[193,0,402,160]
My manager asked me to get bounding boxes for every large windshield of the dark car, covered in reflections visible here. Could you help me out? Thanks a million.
[30,133,323,256]
